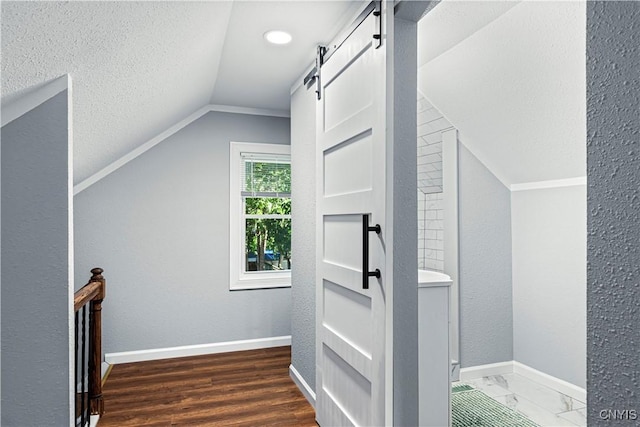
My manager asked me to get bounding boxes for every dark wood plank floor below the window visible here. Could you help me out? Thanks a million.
[98,347,317,427]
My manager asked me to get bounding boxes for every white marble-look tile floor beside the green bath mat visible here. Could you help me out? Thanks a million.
[453,374,587,427]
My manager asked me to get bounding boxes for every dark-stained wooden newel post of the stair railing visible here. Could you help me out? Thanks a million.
[89,268,107,415]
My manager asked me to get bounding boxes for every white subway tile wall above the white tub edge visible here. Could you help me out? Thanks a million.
[417,94,452,271]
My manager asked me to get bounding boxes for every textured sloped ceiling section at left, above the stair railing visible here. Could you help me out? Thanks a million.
[2,2,231,186]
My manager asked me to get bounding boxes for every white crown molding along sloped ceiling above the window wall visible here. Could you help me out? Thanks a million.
[72,104,290,196]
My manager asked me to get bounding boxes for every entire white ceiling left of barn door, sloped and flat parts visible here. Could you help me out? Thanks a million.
[1,1,357,183]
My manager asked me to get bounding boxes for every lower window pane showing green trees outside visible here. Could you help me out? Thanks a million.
[244,218,291,271]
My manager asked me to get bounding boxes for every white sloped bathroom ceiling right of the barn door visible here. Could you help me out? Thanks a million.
[418,1,586,185]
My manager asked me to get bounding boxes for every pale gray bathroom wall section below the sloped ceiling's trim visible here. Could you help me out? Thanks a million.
[511,186,587,387]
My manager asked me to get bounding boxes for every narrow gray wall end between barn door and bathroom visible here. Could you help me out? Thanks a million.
[387,15,420,426]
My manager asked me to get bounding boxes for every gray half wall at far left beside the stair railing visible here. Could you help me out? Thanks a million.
[1,90,73,427]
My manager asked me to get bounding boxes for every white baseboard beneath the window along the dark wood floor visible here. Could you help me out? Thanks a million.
[104,335,291,365]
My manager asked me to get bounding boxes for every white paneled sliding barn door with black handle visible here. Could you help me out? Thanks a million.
[316,2,388,427]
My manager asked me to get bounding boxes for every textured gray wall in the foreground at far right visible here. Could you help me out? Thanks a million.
[587,2,640,426]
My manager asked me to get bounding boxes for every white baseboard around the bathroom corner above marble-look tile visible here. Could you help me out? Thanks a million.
[460,360,587,402]
